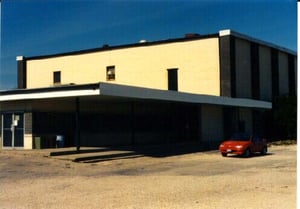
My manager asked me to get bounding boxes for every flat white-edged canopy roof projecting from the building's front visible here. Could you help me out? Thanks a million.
[0,82,272,109]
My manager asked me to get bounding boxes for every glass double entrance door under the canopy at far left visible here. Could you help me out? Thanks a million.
[2,113,24,148]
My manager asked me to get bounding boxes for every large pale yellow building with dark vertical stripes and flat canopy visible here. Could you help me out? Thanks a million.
[0,30,297,149]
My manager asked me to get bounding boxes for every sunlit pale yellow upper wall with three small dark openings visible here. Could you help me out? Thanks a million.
[27,37,220,96]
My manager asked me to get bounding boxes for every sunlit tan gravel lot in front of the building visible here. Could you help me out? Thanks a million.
[0,145,297,209]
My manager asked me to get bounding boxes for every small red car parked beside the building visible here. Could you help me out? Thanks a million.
[219,133,268,157]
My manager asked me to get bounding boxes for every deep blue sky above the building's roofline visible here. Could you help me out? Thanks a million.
[0,0,297,89]
